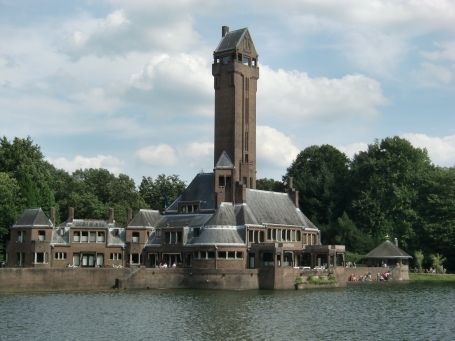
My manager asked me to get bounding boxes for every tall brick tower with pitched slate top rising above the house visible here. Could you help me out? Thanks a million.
[212,26,259,206]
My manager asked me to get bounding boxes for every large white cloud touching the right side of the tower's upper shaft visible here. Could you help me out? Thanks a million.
[258,66,387,124]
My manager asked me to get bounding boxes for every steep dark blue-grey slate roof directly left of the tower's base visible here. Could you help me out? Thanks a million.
[166,173,215,212]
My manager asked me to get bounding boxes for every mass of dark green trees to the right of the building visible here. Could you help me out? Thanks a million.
[257,137,455,270]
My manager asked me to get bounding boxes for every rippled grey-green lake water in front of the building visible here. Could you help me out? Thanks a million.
[0,283,455,341]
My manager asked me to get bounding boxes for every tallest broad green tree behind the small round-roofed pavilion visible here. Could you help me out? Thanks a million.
[349,137,433,248]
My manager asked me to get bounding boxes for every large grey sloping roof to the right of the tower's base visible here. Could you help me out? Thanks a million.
[243,188,316,228]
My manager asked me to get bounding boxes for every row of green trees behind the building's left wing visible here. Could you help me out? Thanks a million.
[0,137,186,261]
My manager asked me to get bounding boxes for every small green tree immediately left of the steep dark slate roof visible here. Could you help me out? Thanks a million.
[139,174,186,210]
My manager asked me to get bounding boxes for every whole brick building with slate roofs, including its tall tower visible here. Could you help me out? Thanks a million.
[6,26,344,271]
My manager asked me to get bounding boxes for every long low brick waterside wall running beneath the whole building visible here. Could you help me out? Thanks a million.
[0,267,346,292]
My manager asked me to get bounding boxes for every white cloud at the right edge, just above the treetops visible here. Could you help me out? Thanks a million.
[401,133,455,167]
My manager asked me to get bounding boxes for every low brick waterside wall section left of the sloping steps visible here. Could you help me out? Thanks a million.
[0,268,130,292]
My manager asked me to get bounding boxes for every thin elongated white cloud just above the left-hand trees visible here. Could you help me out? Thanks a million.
[46,155,125,175]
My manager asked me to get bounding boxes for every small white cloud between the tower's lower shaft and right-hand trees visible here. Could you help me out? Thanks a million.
[256,126,300,168]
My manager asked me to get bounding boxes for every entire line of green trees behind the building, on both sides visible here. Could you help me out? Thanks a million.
[0,137,455,269]
